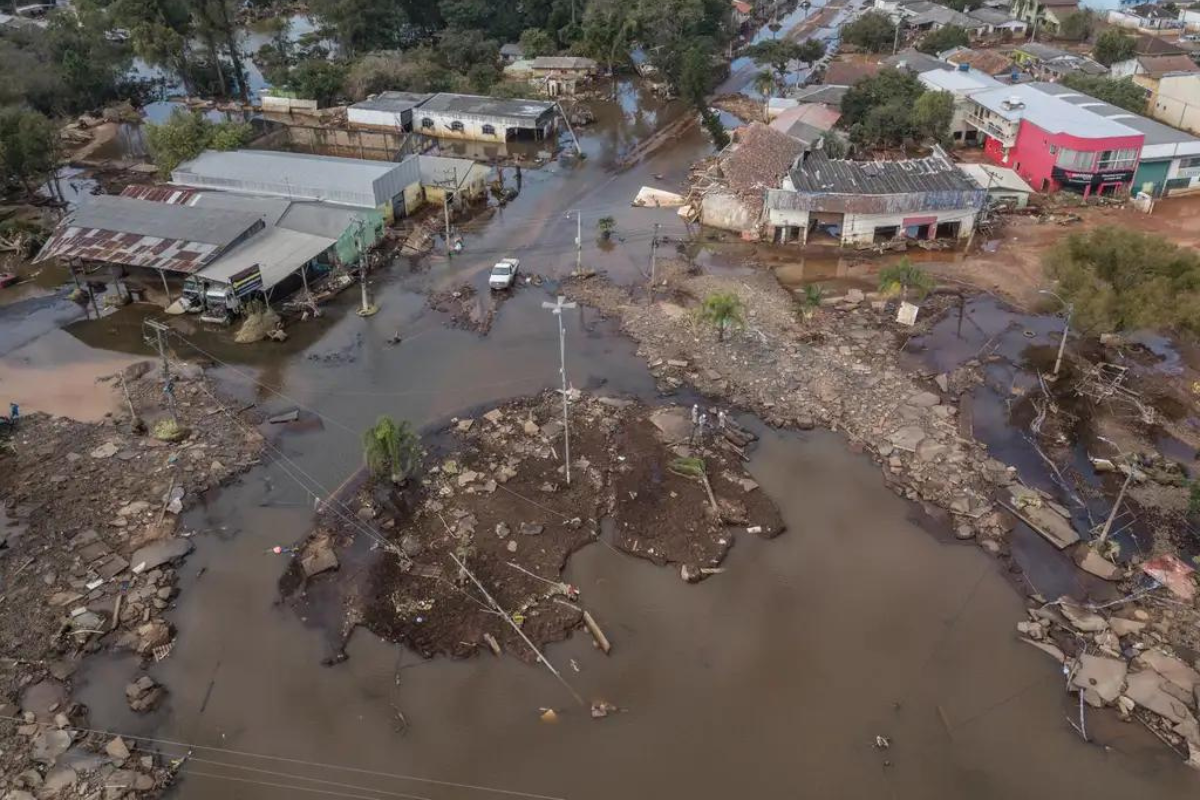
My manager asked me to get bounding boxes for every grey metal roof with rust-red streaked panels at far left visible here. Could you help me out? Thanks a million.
[35,194,263,273]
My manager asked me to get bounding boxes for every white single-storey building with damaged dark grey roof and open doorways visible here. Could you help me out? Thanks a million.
[764,148,986,246]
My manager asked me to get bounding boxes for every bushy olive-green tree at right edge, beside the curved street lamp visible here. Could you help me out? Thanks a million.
[1044,225,1200,333]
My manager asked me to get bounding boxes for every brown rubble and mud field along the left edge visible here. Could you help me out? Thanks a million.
[0,362,264,800]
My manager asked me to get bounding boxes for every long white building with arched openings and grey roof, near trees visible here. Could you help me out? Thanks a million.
[413,92,558,142]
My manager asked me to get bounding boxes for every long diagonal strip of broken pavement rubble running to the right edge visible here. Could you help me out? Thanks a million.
[565,261,1200,766]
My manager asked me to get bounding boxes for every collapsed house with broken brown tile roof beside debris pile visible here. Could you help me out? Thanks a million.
[694,122,804,239]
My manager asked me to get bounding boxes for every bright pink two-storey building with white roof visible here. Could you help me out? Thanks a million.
[966,83,1146,197]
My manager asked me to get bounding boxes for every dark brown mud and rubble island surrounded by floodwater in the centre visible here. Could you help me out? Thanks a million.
[281,390,782,662]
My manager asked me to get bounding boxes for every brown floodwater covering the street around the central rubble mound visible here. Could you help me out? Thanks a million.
[9,5,1195,800]
